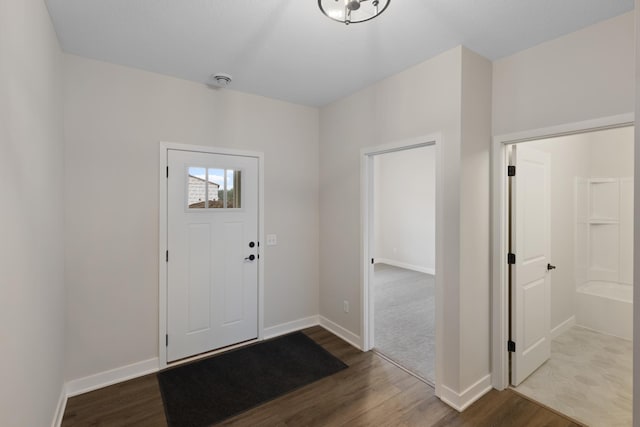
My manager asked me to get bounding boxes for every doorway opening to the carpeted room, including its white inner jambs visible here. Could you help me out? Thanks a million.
[363,138,442,394]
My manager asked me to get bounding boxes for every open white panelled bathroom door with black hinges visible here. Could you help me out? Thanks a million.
[511,145,551,385]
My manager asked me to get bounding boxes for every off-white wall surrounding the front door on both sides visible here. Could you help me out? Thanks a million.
[64,55,319,380]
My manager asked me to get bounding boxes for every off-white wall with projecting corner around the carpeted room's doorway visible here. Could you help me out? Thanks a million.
[320,47,491,402]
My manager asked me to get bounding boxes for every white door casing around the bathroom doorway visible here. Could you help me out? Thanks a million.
[491,113,635,390]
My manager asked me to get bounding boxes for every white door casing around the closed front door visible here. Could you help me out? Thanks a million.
[158,141,265,369]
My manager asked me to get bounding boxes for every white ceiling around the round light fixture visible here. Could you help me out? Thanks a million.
[46,0,634,106]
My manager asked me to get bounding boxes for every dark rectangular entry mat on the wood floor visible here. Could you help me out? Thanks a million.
[158,332,347,427]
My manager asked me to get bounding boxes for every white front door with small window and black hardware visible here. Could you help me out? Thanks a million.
[167,150,259,362]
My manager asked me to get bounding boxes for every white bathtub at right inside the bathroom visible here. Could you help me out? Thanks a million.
[576,281,633,340]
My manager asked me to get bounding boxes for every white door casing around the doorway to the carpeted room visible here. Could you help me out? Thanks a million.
[360,133,444,396]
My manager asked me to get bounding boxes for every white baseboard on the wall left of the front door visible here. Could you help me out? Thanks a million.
[66,357,158,397]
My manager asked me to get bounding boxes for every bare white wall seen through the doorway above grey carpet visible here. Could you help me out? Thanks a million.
[374,146,436,274]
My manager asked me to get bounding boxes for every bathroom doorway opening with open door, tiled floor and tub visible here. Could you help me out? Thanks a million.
[507,126,634,425]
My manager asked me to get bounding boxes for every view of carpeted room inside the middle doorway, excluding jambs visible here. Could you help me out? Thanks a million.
[372,146,436,385]
